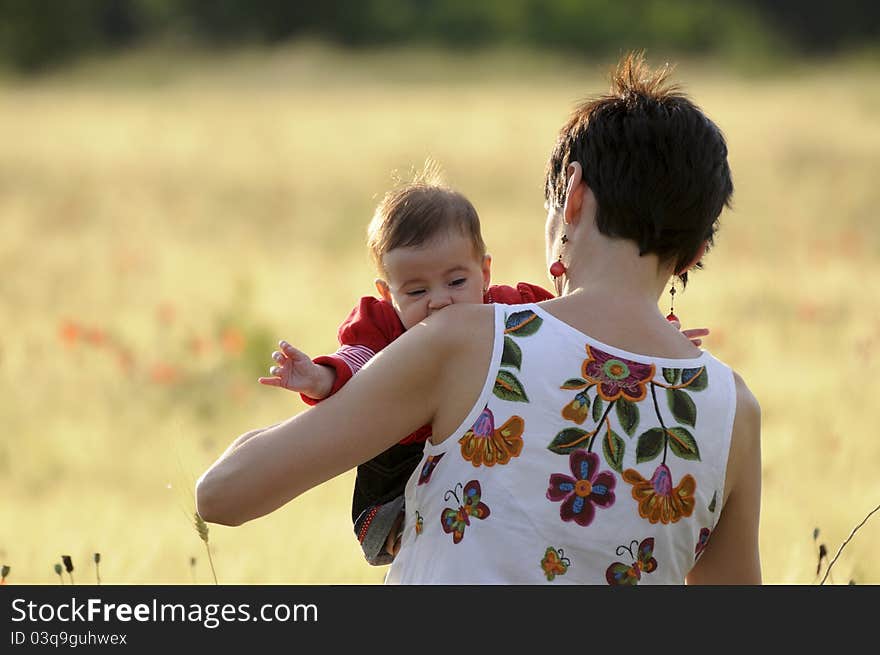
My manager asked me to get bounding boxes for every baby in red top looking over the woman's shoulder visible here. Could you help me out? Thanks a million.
[260,176,553,565]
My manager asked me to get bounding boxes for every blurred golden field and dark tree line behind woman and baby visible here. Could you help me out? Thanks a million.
[0,0,880,584]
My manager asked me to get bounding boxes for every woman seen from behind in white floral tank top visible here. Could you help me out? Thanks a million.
[197,56,761,584]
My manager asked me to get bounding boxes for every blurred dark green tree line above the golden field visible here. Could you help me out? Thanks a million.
[0,0,880,73]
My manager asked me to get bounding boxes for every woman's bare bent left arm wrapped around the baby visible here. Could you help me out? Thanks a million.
[196,305,492,525]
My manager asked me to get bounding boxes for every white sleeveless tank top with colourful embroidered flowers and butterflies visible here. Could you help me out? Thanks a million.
[386,304,736,585]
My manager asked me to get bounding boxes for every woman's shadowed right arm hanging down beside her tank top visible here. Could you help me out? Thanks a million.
[687,373,761,585]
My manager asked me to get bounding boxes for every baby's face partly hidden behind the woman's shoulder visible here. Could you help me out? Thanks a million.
[376,232,492,330]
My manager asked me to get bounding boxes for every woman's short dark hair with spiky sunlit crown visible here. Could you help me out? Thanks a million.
[544,53,733,283]
